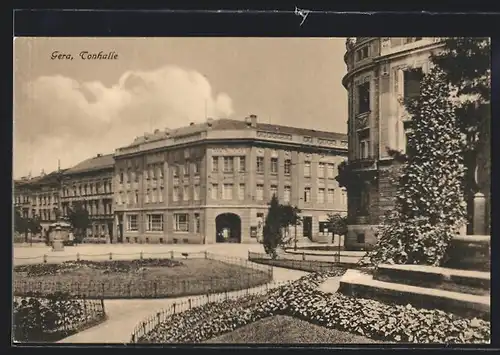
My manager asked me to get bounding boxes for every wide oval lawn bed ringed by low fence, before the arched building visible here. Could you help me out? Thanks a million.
[13,258,272,299]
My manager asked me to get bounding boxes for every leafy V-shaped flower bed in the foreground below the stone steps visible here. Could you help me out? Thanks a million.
[139,272,491,343]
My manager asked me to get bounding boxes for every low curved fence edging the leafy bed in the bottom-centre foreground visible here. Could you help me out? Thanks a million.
[130,281,292,343]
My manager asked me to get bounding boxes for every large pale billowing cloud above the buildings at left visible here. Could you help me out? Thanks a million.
[14,66,233,177]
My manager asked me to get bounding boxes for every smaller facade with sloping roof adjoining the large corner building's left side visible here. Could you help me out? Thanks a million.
[60,154,114,241]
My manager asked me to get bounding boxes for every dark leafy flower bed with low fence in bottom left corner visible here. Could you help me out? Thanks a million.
[13,293,106,342]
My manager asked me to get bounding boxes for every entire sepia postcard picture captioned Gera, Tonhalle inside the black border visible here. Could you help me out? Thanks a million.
[11,35,491,346]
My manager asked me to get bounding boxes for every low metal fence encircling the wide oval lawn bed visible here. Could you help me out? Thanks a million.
[13,251,273,299]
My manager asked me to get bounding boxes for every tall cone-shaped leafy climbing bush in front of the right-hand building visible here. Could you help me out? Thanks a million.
[371,67,466,265]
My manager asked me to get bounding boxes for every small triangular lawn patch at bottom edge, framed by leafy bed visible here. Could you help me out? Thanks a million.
[205,315,377,344]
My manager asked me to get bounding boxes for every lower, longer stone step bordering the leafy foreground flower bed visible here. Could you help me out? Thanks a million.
[339,269,490,320]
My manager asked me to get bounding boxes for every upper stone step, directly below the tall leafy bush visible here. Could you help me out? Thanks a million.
[374,264,491,295]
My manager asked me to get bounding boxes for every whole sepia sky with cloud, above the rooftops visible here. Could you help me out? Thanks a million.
[13,38,347,178]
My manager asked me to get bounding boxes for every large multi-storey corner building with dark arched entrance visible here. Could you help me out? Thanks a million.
[113,115,347,244]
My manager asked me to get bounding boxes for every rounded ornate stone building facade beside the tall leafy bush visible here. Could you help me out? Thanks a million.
[343,37,489,250]
